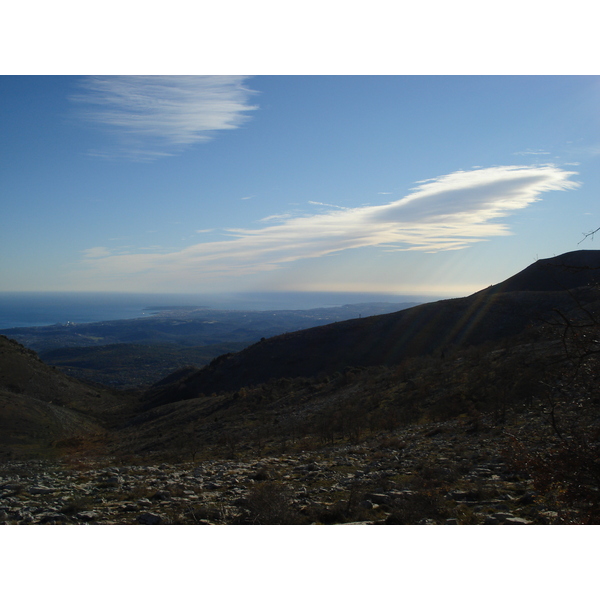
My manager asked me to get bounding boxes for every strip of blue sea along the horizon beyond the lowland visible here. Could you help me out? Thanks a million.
[0,292,439,330]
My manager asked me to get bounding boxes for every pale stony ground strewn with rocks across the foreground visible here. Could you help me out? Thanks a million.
[0,420,558,525]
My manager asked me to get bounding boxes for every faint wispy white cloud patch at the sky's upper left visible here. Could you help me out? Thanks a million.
[71,75,257,160]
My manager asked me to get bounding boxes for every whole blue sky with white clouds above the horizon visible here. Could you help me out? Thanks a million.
[0,75,600,297]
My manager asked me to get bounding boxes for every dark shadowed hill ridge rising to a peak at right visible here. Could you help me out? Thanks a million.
[142,251,600,407]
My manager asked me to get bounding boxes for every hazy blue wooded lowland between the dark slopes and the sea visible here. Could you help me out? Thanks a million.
[0,302,415,389]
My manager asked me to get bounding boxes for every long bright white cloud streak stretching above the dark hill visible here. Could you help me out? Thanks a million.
[77,165,579,285]
